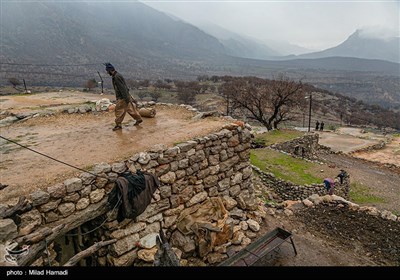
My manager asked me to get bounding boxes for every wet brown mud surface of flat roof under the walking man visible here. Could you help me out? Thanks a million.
[0,106,226,202]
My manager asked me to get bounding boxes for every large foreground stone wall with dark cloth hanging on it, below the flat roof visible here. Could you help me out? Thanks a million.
[0,121,265,266]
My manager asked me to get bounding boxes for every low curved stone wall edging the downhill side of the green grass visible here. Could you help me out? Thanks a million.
[252,166,350,200]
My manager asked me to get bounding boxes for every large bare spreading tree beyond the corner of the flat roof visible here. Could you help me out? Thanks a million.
[221,75,304,130]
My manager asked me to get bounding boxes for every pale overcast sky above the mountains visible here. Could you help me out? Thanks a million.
[141,0,400,50]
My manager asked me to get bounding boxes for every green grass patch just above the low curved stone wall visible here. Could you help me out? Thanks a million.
[250,148,326,185]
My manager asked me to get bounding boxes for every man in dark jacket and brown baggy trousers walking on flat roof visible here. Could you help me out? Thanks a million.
[104,63,143,131]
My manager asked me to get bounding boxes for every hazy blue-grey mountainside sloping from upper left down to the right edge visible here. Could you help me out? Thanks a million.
[0,1,400,110]
